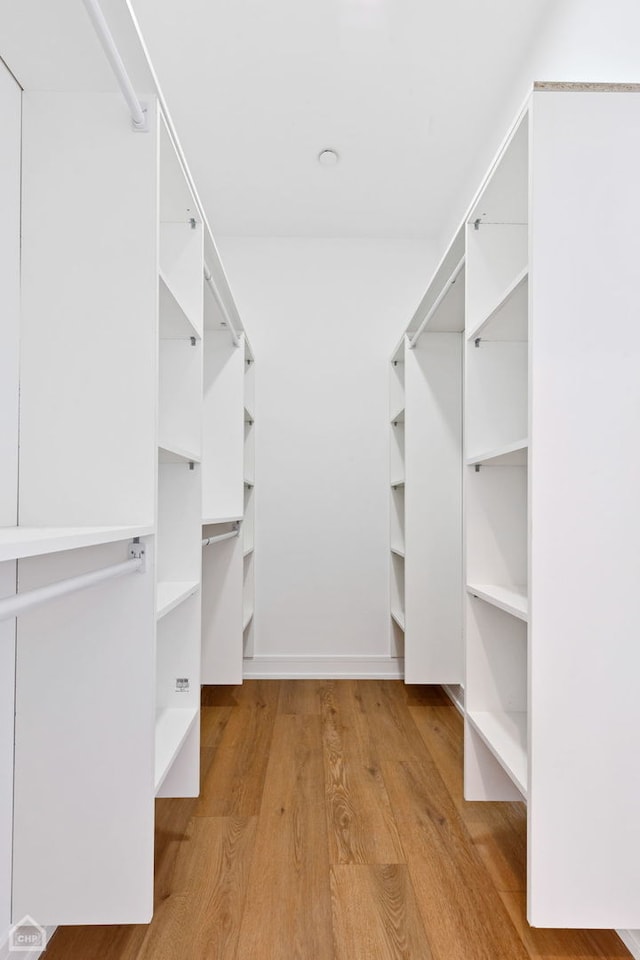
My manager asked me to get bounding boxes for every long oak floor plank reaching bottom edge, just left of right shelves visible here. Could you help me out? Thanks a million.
[383,761,527,960]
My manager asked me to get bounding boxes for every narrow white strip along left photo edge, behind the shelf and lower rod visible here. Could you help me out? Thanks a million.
[0,63,20,943]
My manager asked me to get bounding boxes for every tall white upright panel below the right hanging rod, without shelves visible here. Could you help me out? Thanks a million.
[405,333,463,683]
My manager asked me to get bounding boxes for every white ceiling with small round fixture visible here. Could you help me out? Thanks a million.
[133,0,553,237]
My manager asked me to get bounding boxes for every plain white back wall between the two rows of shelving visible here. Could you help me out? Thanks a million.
[220,238,432,673]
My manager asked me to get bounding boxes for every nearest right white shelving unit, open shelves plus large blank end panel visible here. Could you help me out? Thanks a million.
[464,84,640,928]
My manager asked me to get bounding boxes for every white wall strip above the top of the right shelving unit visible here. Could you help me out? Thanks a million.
[436,0,640,251]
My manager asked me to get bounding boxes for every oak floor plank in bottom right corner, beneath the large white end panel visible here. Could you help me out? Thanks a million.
[501,892,631,960]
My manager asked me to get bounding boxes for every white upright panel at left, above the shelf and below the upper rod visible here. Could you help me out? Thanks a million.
[20,93,158,526]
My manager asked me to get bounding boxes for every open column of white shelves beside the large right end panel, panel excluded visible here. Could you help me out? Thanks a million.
[465,107,529,816]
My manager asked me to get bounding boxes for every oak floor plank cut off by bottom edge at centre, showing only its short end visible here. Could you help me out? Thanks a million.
[331,864,432,960]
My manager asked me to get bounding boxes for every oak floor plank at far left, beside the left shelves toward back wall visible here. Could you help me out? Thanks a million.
[194,681,279,817]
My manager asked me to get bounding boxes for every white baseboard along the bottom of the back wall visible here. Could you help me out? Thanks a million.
[243,655,404,680]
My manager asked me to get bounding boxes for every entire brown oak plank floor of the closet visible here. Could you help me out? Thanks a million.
[46,680,630,960]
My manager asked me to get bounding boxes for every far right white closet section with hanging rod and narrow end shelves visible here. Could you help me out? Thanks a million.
[390,232,465,684]
